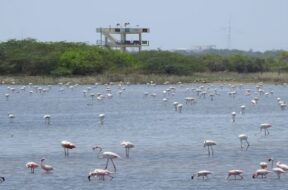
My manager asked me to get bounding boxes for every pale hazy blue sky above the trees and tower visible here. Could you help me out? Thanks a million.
[0,0,288,51]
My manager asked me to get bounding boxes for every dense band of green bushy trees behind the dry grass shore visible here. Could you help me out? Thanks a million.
[0,39,288,76]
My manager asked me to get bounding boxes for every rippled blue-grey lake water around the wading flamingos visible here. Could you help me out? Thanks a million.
[0,84,288,190]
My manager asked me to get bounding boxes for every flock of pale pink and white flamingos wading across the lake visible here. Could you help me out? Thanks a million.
[0,82,288,183]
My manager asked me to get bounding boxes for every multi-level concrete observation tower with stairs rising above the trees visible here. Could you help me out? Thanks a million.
[96,23,150,52]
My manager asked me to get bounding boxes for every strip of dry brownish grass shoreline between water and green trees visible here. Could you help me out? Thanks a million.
[0,72,288,85]
